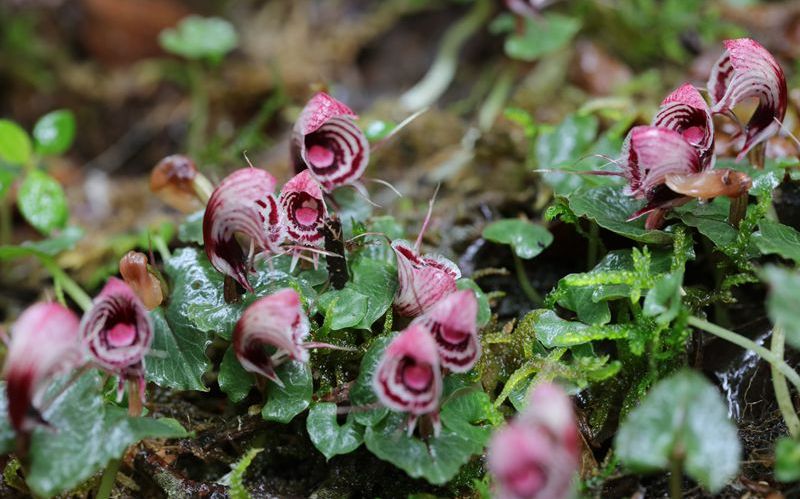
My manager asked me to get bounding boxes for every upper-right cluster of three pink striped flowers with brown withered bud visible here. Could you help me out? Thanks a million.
[621,38,787,229]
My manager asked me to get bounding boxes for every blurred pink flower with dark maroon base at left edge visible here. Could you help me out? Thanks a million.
[3,303,81,433]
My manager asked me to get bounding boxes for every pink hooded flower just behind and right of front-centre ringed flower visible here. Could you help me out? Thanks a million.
[414,289,481,373]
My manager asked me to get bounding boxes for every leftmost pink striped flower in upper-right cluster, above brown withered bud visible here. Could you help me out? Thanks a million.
[622,126,702,200]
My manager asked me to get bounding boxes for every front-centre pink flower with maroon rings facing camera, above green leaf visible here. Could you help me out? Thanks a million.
[373,324,442,416]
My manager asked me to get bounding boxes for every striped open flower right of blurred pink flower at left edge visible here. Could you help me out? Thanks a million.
[80,277,153,413]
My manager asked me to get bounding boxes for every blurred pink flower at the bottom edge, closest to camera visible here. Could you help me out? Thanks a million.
[488,384,580,499]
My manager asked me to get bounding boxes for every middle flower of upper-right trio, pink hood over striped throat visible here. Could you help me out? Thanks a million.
[652,83,714,169]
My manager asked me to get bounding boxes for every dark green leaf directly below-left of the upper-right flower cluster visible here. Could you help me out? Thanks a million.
[568,186,672,244]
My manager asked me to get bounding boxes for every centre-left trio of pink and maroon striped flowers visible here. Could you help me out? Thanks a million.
[203,93,369,292]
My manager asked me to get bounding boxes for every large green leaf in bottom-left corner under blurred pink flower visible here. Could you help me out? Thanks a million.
[9,372,188,497]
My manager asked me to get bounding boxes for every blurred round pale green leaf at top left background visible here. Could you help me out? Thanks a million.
[158,16,239,64]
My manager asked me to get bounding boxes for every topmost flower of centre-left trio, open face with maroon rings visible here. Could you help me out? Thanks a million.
[292,92,369,192]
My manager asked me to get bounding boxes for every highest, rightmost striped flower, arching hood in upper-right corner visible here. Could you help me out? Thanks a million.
[708,38,788,159]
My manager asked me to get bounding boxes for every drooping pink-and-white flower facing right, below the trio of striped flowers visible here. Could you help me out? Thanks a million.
[233,288,310,386]
